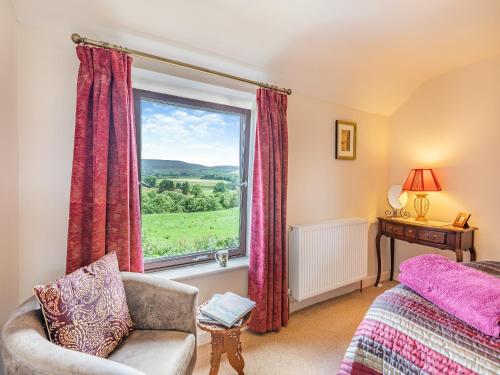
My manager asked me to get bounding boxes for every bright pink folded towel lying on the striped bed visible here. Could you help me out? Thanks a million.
[399,254,500,337]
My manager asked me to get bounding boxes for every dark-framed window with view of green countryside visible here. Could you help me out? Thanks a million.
[134,89,251,270]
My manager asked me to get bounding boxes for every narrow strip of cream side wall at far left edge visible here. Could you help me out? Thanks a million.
[0,0,18,332]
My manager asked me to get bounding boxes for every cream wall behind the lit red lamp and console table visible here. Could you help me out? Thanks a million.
[390,56,500,264]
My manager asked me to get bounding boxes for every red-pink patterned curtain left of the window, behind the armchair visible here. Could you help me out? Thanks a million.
[66,46,144,273]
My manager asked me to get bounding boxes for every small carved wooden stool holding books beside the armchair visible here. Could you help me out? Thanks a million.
[197,305,251,375]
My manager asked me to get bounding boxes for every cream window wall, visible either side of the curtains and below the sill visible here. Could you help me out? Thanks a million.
[13,25,389,306]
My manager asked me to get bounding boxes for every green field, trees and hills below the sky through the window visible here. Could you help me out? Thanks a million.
[141,159,240,259]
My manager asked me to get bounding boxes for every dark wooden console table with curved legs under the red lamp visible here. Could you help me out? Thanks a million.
[375,217,478,286]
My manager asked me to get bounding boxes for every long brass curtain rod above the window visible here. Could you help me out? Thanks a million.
[71,33,292,95]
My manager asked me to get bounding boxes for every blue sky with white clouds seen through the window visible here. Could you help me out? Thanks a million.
[141,99,240,166]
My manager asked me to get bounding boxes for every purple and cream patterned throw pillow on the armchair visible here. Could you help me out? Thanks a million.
[34,252,133,358]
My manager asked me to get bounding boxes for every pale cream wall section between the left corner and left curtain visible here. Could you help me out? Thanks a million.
[18,25,78,300]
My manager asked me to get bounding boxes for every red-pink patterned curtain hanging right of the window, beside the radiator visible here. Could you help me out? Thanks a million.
[248,89,288,333]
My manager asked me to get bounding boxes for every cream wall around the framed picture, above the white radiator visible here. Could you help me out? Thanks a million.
[288,94,389,282]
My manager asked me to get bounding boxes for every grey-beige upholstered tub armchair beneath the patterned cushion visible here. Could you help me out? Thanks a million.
[1,272,198,375]
